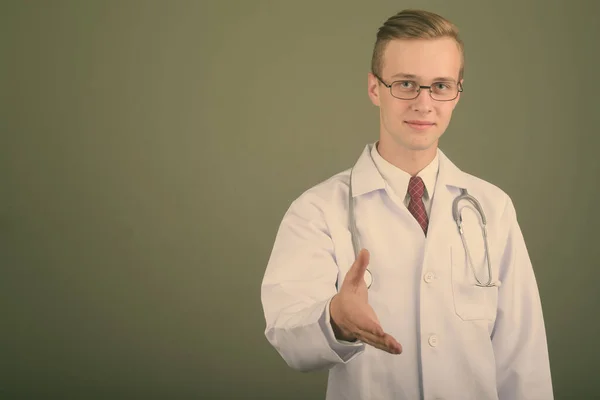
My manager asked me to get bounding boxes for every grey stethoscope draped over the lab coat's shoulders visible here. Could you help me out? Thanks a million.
[348,169,497,288]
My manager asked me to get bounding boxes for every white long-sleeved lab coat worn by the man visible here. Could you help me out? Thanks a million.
[261,144,553,400]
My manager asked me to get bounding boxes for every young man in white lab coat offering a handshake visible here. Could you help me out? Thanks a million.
[261,10,553,400]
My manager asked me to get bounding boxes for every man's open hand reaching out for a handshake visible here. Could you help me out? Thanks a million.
[329,249,402,354]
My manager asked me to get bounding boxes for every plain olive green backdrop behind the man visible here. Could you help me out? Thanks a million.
[0,0,600,400]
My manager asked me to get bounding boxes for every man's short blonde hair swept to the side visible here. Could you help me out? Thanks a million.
[371,10,465,81]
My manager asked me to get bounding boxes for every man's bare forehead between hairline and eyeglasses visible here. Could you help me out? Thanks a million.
[381,38,461,80]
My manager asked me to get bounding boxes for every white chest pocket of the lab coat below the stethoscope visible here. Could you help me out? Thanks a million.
[450,245,498,321]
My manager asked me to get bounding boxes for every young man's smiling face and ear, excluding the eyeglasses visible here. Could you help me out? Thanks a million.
[368,38,462,153]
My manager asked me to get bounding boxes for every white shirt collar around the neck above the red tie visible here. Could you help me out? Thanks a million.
[371,143,440,199]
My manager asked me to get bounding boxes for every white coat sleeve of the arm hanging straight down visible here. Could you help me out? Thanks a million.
[492,199,553,400]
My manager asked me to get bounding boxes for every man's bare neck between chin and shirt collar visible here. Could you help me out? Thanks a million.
[377,140,437,176]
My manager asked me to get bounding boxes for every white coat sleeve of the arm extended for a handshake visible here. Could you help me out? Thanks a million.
[261,194,365,371]
